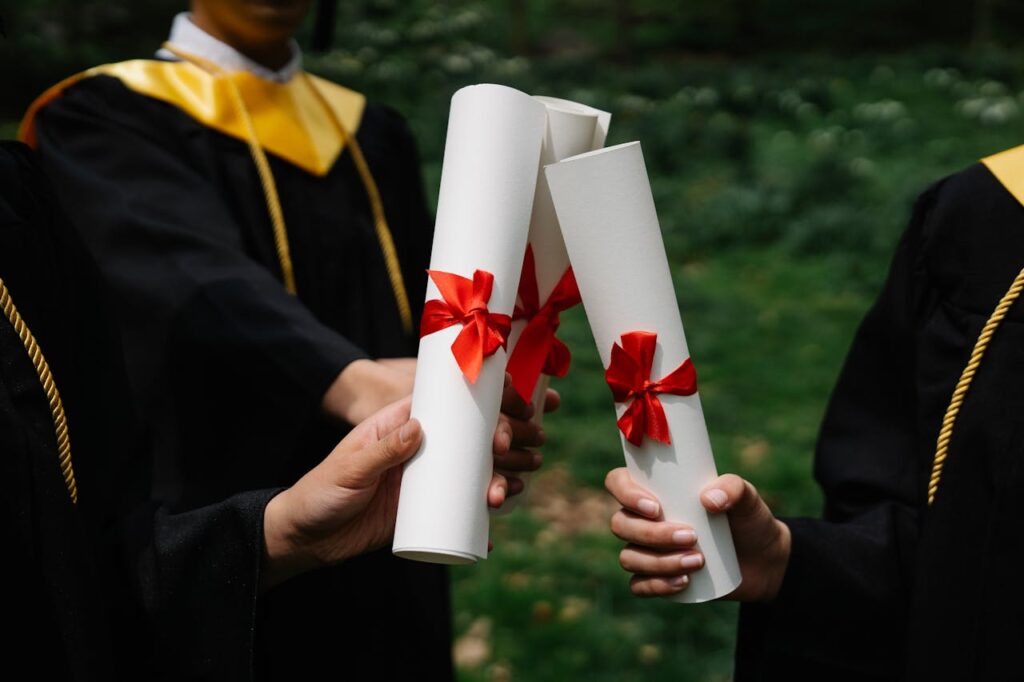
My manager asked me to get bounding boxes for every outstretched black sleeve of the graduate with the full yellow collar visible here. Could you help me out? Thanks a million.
[29,76,367,411]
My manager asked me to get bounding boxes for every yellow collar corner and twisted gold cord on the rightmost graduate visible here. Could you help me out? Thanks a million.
[928,145,1024,505]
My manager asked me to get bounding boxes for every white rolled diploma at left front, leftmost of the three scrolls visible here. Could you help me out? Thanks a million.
[392,85,545,563]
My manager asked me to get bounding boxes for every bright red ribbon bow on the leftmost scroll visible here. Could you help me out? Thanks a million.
[420,270,512,383]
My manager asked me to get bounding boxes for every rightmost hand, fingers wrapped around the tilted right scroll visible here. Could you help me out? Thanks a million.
[604,468,790,601]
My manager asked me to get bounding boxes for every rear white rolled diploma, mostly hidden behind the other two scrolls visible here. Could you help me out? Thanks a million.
[490,96,611,516]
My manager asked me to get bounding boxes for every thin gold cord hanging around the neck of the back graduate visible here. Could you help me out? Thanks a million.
[164,43,413,334]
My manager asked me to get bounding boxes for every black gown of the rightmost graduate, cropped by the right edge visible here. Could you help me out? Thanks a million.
[735,164,1024,682]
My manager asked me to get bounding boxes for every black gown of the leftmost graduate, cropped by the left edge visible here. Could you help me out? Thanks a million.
[0,143,275,681]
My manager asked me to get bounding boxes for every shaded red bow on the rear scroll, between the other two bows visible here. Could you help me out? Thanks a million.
[507,245,580,402]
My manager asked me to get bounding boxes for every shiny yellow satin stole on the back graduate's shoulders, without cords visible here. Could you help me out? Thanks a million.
[18,59,366,176]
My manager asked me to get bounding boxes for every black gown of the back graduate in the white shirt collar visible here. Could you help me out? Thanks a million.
[30,66,453,680]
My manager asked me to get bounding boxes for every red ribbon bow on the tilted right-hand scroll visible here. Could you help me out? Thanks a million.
[604,332,697,445]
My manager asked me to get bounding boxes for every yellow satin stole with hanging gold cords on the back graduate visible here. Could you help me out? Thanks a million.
[18,57,413,334]
